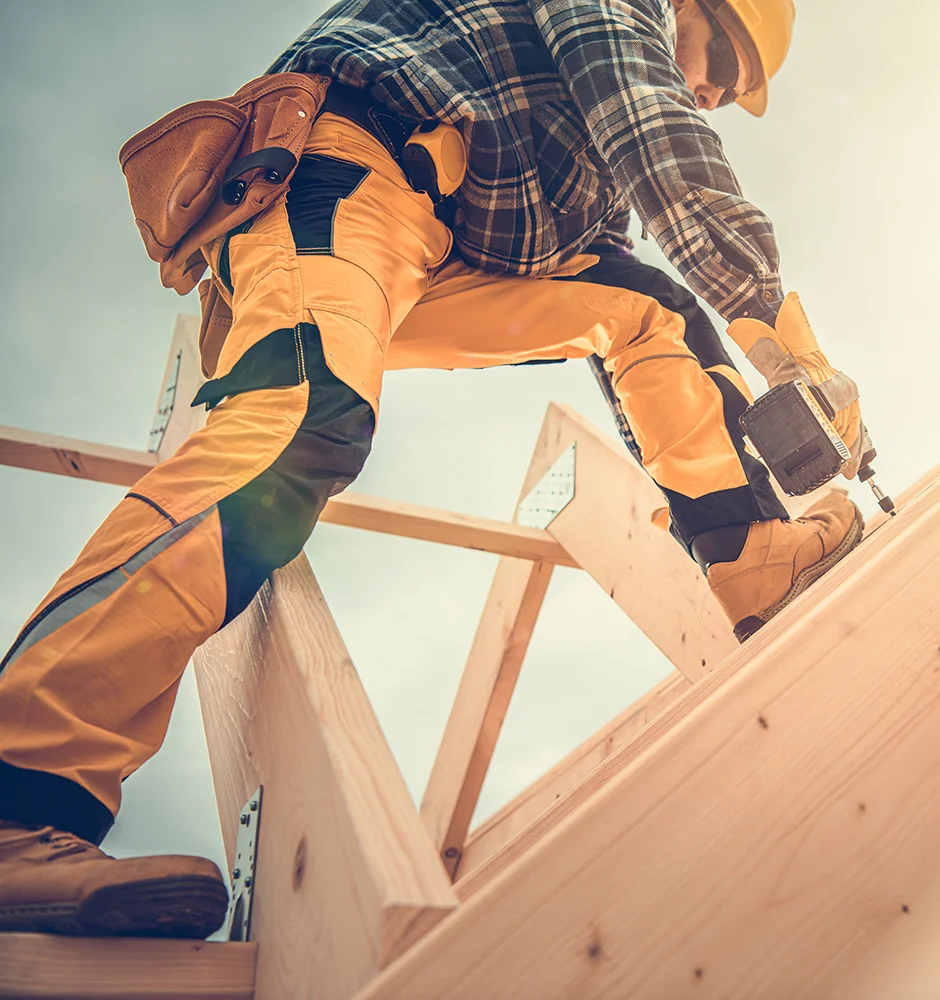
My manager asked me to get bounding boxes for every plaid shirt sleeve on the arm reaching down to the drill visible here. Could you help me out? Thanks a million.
[529,0,783,323]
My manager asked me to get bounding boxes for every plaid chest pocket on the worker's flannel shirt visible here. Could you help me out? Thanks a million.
[531,101,602,214]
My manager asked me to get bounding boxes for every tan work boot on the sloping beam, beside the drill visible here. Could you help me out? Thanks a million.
[706,493,865,642]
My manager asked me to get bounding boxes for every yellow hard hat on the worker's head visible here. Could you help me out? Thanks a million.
[707,0,796,118]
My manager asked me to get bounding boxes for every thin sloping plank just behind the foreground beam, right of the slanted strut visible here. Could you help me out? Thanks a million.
[454,671,691,899]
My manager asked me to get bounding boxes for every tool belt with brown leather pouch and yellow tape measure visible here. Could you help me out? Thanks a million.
[119,73,467,295]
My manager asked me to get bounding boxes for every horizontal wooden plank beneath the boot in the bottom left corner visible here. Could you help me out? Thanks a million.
[0,934,257,1000]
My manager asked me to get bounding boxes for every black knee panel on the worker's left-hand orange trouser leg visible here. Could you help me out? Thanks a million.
[207,323,375,624]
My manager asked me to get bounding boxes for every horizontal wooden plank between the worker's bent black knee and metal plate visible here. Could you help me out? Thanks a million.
[320,493,577,566]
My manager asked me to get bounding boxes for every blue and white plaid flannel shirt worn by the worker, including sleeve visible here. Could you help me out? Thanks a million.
[269,0,783,323]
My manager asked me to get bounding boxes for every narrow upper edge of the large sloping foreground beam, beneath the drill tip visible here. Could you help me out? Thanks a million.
[457,476,940,900]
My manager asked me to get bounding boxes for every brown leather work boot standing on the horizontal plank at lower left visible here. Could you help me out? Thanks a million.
[0,820,228,938]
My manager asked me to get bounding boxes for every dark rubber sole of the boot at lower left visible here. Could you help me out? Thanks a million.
[0,875,228,938]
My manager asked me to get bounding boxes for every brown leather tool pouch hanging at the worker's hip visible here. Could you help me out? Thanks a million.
[119,73,330,295]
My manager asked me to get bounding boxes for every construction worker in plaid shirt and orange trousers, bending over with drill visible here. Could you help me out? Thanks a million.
[0,0,862,936]
